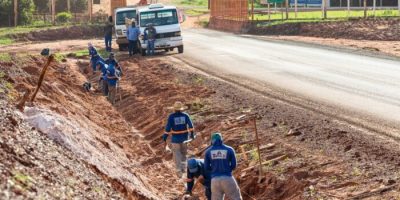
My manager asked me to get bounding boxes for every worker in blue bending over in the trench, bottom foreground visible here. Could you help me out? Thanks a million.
[185,158,211,200]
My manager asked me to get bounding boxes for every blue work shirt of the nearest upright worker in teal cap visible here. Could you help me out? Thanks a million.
[204,139,236,178]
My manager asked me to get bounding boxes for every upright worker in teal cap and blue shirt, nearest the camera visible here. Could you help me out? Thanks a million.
[204,133,242,200]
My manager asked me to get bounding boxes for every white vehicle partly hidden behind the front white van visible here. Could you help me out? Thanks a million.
[114,6,137,51]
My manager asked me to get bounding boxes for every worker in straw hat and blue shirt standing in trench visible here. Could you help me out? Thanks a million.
[162,101,195,178]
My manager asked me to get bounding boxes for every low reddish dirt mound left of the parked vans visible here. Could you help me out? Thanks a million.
[9,25,103,42]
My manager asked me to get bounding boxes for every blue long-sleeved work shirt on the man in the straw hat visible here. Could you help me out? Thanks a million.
[165,112,193,143]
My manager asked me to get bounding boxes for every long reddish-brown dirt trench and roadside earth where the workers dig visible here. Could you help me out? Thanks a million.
[0,41,400,200]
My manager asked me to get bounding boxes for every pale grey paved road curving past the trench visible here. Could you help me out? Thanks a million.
[178,29,400,132]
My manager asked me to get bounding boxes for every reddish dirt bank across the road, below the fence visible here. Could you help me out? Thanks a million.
[249,19,400,41]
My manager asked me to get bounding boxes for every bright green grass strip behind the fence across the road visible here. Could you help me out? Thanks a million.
[250,10,399,21]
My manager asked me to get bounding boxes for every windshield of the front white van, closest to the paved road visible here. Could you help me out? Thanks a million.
[140,9,178,27]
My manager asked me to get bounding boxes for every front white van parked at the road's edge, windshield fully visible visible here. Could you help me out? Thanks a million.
[137,4,183,56]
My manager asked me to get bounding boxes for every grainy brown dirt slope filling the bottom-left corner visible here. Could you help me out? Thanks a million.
[0,99,122,199]
